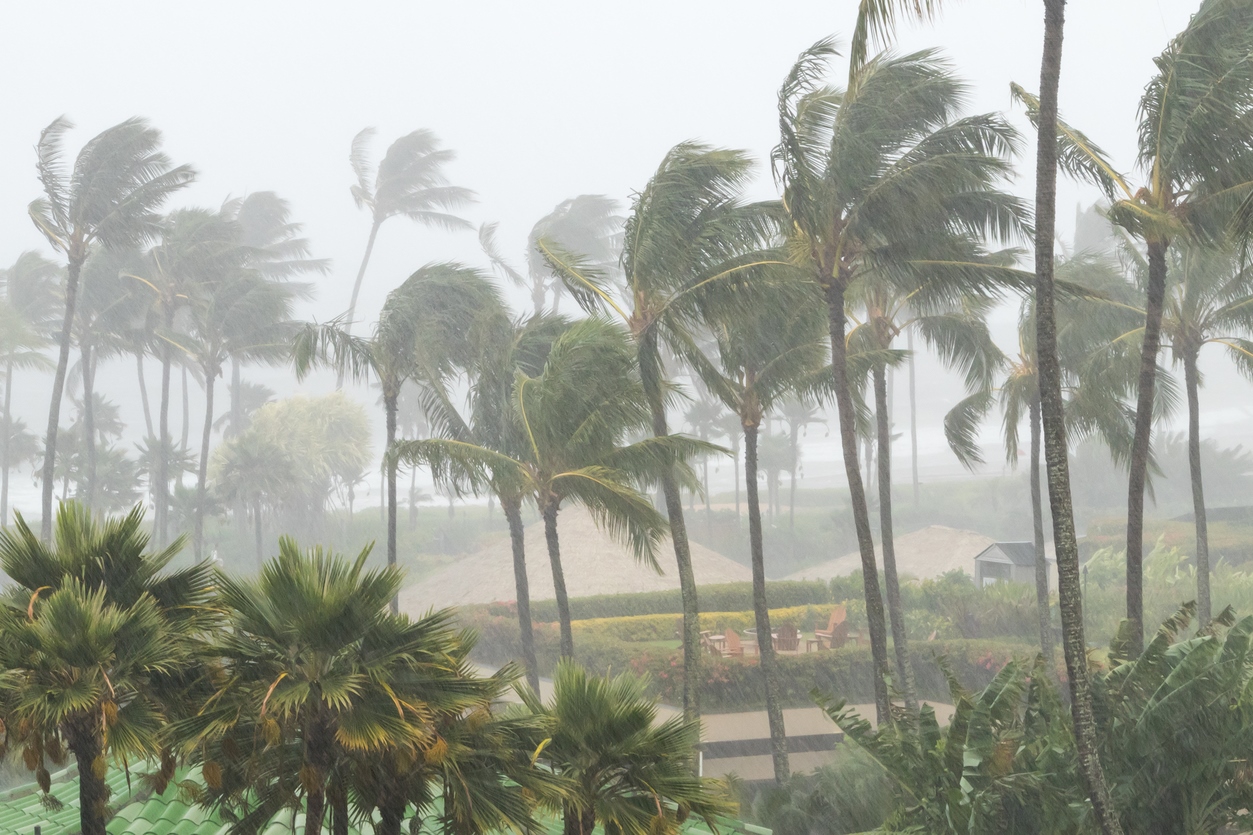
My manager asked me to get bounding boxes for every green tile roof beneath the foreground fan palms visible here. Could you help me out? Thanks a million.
[0,766,771,835]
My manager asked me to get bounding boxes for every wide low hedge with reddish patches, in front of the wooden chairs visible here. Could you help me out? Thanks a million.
[460,611,1034,711]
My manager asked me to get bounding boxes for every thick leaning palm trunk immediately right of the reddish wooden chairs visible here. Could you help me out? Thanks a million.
[819,277,891,725]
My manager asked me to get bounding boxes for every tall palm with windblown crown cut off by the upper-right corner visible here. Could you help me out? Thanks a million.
[1015,0,1253,652]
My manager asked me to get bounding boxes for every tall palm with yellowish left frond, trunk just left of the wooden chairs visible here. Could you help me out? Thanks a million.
[536,142,778,718]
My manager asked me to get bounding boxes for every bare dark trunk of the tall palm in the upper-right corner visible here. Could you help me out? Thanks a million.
[1126,241,1167,657]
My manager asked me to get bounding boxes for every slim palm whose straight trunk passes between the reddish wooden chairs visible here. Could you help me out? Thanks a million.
[692,285,827,785]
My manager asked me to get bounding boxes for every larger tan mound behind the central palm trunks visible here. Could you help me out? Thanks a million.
[400,507,752,614]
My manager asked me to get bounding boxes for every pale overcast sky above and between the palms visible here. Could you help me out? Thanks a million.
[0,0,1227,501]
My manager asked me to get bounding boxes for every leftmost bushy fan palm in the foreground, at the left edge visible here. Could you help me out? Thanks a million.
[0,503,216,835]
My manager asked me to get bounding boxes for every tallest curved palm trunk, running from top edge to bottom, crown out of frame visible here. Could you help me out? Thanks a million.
[1035,0,1123,835]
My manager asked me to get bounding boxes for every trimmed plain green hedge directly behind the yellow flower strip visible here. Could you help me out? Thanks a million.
[476,580,832,622]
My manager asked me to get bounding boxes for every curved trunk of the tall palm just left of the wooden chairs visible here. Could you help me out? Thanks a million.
[638,341,701,722]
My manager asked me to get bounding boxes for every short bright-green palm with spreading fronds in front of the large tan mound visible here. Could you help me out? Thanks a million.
[393,318,709,657]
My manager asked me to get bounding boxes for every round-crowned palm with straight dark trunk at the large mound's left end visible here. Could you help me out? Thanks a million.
[292,263,504,611]
